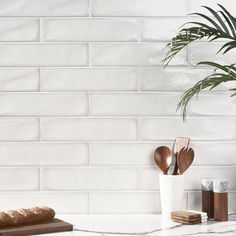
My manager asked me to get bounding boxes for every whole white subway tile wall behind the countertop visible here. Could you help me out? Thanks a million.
[0,0,236,214]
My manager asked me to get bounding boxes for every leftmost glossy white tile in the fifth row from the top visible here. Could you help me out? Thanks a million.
[0,93,88,116]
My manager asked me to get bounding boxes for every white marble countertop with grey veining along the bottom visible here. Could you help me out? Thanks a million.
[42,214,236,236]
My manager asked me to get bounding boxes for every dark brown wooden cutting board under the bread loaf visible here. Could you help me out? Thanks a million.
[0,218,73,236]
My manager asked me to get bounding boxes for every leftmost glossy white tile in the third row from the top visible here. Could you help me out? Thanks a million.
[0,43,88,66]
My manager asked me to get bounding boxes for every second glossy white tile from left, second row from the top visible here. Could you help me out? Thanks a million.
[42,18,138,42]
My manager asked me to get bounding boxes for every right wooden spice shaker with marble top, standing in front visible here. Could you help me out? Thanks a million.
[213,179,228,221]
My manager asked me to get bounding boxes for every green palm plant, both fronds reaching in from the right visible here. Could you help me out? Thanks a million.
[163,4,236,119]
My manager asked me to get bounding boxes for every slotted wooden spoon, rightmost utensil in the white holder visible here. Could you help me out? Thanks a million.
[177,147,194,175]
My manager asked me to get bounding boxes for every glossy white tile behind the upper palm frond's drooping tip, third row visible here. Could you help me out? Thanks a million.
[91,43,187,67]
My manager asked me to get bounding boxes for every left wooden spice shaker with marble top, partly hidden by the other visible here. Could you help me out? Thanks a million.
[201,179,214,219]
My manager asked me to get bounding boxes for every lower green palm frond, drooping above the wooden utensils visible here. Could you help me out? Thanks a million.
[177,61,236,120]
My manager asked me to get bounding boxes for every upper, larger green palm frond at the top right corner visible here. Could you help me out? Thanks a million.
[162,4,236,66]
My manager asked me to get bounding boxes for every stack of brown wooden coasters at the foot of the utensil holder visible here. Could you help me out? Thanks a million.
[171,211,202,225]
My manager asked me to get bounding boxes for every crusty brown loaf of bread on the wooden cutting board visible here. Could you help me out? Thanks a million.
[0,206,55,227]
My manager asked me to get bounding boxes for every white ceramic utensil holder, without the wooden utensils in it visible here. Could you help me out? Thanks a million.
[159,174,184,218]
